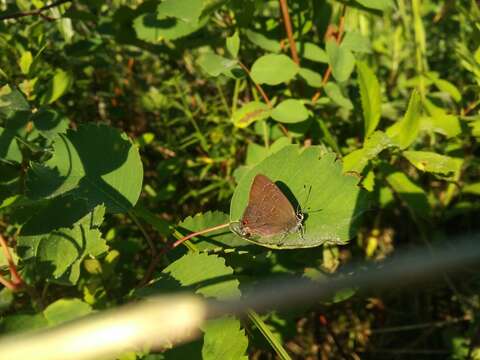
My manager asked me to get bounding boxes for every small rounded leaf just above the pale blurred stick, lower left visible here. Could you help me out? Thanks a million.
[43,299,92,326]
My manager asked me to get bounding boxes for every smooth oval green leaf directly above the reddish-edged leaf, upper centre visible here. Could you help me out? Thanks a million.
[251,54,299,85]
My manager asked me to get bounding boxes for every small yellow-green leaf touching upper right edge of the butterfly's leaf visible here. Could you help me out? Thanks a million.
[343,131,394,173]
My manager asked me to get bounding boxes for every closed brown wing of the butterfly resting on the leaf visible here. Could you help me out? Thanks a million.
[241,174,297,237]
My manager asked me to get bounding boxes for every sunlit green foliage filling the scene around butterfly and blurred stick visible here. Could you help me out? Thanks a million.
[0,0,480,359]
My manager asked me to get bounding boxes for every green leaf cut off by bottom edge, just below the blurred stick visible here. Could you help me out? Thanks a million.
[202,316,248,360]
